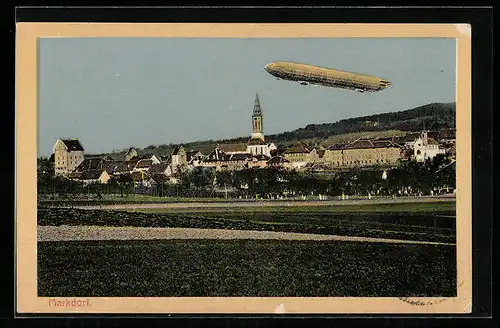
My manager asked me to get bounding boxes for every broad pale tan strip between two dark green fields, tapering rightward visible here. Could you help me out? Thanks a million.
[38,225,455,246]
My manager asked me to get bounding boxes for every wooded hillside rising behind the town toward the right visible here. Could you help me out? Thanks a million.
[89,102,456,159]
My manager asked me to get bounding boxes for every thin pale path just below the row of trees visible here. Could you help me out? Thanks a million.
[74,197,456,210]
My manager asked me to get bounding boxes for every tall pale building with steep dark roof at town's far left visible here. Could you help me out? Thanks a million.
[52,139,84,175]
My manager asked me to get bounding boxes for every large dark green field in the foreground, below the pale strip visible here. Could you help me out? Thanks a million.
[38,240,456,297]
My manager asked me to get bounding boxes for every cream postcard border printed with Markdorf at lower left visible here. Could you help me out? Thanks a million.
[15,23,472,314]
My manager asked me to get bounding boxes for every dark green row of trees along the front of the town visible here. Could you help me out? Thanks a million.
[38,155,455,198]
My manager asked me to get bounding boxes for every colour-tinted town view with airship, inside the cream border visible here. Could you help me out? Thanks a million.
[37,37,457,297]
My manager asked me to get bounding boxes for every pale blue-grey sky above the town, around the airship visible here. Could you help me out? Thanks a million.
[38,38,456,156]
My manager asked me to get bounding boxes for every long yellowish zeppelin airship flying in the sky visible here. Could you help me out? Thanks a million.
[265,62,392,92]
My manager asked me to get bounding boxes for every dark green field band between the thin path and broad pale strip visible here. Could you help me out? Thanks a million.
[38,207,456,243]
